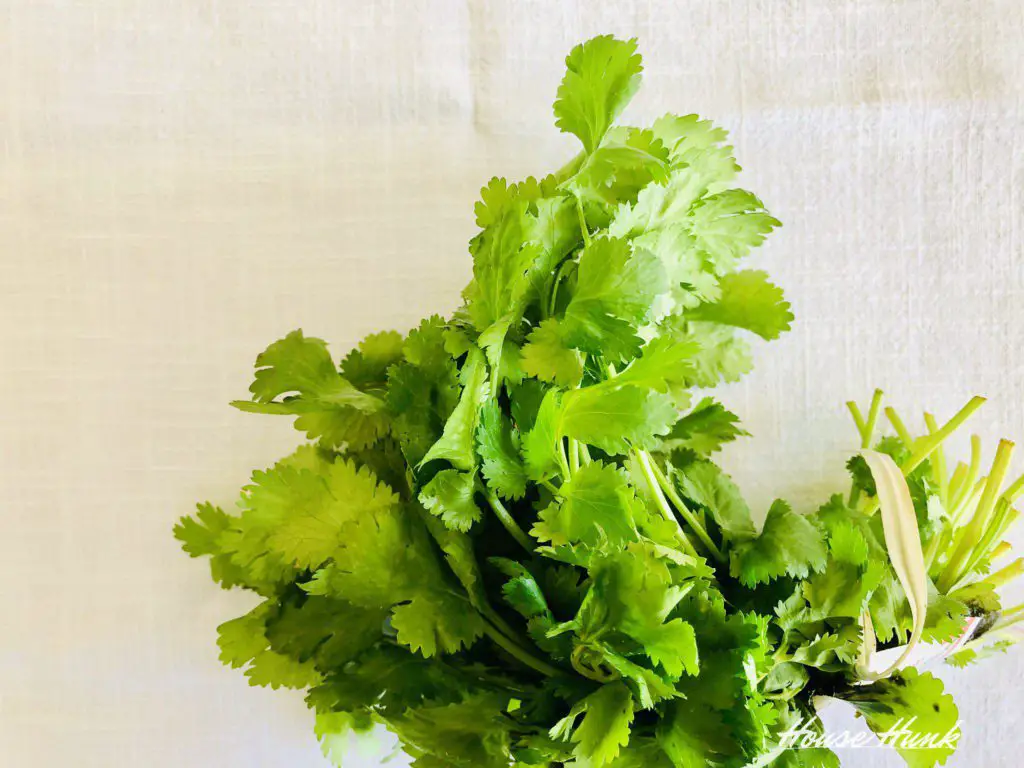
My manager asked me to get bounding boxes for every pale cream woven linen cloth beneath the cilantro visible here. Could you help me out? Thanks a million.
[0,0,1024,768]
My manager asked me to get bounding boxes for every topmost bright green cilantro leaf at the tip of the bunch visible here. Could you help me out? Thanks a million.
[555,35,643,153]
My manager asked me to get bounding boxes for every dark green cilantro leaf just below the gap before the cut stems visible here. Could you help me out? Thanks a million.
[729,501,828,587]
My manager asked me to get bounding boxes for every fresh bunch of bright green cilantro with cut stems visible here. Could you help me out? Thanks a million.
[175,37,1019,768]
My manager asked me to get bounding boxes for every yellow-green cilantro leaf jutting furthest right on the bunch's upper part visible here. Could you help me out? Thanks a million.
[688,270,793,341]
